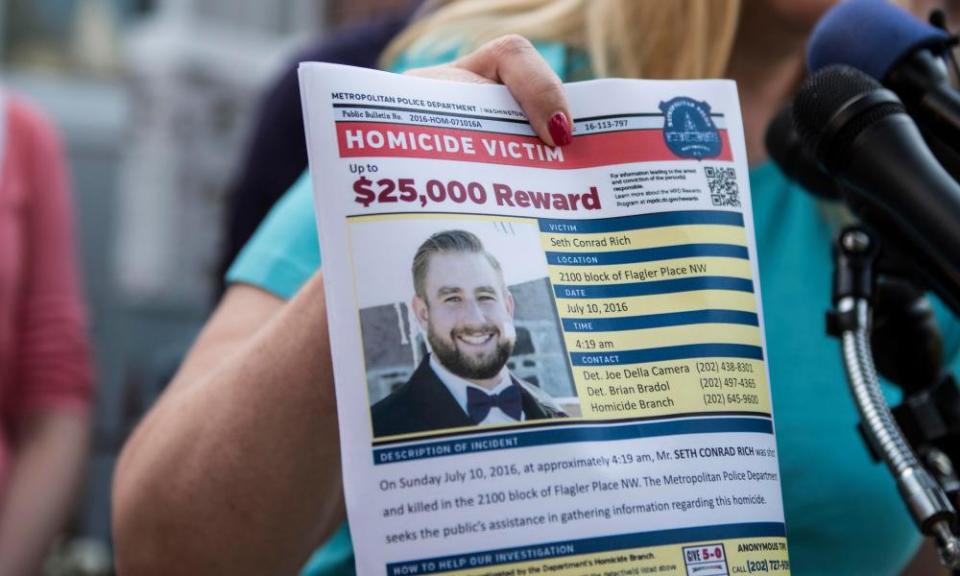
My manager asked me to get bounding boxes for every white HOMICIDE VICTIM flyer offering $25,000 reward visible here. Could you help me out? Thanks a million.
[300,63,790,576]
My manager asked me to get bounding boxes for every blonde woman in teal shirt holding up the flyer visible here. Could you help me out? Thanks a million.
[114,0,960,575]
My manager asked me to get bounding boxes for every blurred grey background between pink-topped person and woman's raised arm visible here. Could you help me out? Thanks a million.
[0,0,409,575]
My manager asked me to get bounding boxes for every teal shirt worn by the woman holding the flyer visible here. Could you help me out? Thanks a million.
[227,46,960,576]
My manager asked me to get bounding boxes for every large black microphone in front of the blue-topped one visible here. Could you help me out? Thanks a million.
[793,66,960,315]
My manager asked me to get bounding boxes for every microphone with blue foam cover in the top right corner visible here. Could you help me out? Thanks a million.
[807,0,960,177]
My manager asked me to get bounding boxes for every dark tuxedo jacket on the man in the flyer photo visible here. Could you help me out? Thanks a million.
[370,356,565,438]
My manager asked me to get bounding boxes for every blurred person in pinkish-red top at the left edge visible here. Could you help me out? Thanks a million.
[0,91,92,576]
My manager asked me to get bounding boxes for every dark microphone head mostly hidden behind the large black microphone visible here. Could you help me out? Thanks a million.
[763,104,840,200]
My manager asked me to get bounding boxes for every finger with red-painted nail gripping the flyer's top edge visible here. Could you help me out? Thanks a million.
[451,34,573,146]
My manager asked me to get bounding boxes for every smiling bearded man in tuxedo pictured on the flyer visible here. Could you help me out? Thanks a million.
[371,230,566,437]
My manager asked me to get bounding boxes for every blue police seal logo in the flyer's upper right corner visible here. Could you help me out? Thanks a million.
[660,96,722,159]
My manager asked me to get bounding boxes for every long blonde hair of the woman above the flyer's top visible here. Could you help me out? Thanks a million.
[380,0,741,78]
